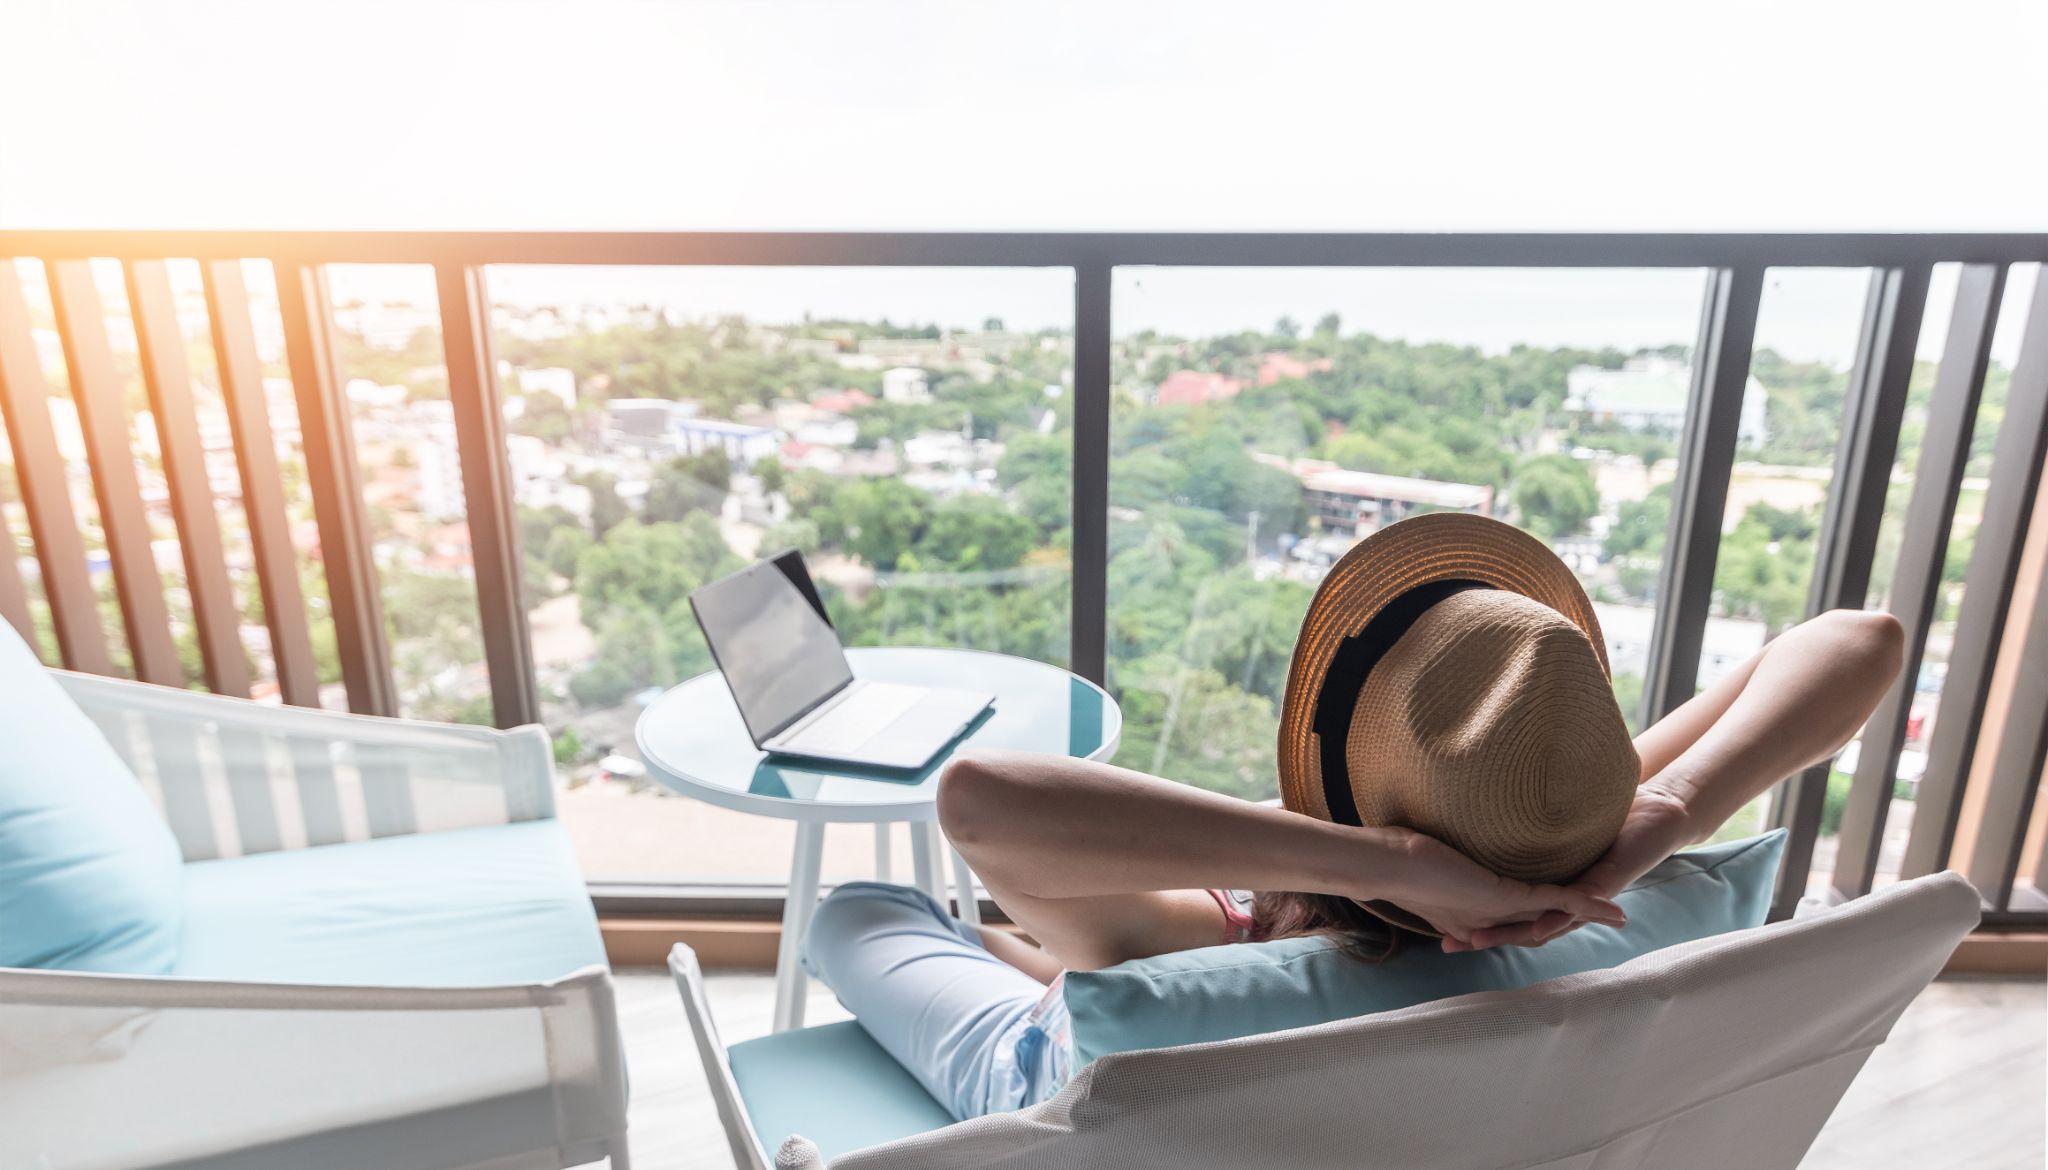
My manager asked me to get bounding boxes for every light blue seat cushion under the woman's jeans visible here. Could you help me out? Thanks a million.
[725,1020,952,1160]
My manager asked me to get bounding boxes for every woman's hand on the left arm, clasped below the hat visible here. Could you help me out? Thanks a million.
[1370,830,1628,953]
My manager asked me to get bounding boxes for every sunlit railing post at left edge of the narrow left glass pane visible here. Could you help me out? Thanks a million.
[276,262,397,715]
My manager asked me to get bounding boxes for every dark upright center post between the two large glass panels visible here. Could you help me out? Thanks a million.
[1069,264,1114,684]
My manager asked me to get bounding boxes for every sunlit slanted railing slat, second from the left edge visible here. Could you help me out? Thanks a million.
[49,260,184,686]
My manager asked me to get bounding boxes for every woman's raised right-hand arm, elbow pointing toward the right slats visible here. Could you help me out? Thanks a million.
[1470,609,1905,947]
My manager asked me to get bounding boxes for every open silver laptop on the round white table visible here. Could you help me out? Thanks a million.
[690,549,995,768]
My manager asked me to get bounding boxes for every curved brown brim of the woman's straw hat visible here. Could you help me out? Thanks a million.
[1278,512,1612,932]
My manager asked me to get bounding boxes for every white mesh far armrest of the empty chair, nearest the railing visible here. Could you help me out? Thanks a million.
[51,670,555,861]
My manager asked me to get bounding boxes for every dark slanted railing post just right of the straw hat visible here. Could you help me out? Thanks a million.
[1642,266,1763,725]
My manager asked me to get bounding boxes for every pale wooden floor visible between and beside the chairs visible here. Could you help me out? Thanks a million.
[618,969,2048,1170]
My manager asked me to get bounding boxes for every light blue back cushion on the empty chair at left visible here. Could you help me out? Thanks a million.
[0,621,182,975]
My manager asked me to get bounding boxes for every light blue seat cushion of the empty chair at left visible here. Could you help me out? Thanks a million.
[176,820,604,988]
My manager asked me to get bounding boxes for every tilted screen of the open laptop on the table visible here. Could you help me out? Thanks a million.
[690,551,854,744]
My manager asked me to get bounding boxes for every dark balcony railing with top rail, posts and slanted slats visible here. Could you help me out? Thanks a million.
[0,232,2048,928]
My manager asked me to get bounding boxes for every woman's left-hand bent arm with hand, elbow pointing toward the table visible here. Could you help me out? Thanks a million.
[938,752,1620,967]
